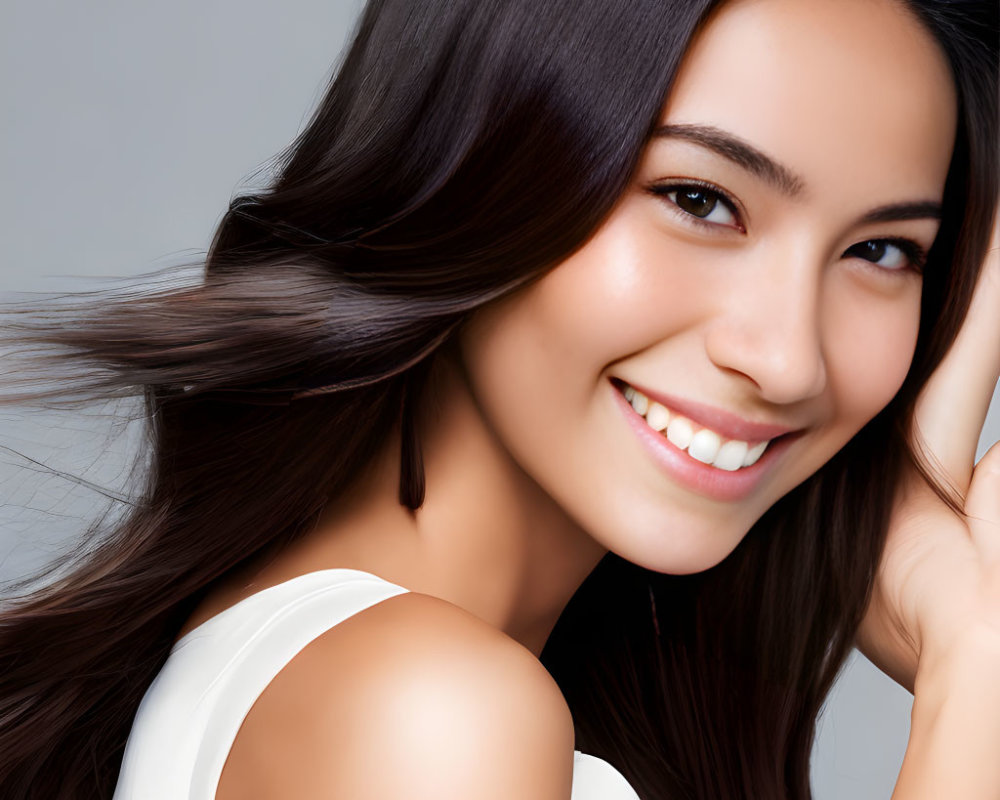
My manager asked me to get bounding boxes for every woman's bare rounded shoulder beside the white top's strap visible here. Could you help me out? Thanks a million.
[216,593,573,800]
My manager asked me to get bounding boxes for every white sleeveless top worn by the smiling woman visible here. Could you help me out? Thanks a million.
[114,569,639,800]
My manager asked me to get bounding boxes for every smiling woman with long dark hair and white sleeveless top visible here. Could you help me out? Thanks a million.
[0,0,1000,800]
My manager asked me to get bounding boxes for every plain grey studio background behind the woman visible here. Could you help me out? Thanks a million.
[0,0,1000,800]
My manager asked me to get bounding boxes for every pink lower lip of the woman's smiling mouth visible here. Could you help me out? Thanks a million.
[611,384,801,502]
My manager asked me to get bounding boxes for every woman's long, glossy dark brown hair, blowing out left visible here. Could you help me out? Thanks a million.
[0,0,997,800]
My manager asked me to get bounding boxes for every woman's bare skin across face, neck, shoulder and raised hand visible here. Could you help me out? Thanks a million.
[182,0,1000,800]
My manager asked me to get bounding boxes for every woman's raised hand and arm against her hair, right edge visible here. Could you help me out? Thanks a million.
[858,203,1000,800]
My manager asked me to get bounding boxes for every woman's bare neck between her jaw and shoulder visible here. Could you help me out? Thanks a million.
[308,358,607,655]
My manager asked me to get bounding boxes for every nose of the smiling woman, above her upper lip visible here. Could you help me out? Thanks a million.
[705,248,827,404]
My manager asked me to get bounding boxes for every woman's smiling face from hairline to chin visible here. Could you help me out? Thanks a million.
[460,0,957,574]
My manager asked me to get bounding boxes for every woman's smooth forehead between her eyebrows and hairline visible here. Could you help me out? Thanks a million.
[661,0,957,199]
